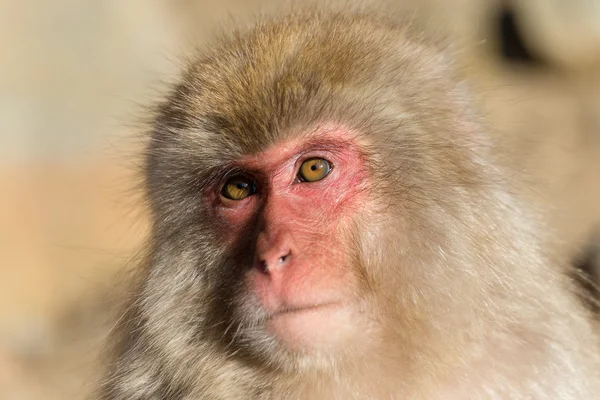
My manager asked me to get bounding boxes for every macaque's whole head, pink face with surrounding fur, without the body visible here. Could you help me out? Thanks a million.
[140,10,540,378]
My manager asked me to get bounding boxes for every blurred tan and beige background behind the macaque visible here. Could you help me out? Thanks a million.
[0,0,600,400]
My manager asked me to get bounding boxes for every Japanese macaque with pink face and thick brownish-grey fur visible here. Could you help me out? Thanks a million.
[99,3,600,400]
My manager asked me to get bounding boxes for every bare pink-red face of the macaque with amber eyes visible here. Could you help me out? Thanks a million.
[206,129,368,348]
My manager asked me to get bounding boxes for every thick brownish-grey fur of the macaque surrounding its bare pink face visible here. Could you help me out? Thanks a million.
[99,6,600,400]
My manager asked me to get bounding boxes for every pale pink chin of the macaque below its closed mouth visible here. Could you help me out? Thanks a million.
[266,302,358,355]
